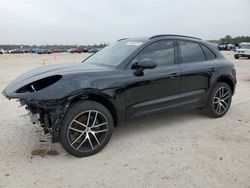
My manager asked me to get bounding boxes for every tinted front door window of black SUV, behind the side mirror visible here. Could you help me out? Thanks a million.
[137,40,174,66]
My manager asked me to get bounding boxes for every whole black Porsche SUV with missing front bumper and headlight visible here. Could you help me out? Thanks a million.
[3,35,236,157]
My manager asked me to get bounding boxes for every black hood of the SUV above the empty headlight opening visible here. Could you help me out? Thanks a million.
[3,63,111,97]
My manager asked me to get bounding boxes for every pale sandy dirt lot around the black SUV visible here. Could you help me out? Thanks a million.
[0,52,250,188]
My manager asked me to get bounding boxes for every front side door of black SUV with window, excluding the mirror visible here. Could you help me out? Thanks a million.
[126,40,180,118]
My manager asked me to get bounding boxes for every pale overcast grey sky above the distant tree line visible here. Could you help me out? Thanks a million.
[0,0,250,45]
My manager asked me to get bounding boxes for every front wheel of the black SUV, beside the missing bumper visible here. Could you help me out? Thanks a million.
[60,100,114,157]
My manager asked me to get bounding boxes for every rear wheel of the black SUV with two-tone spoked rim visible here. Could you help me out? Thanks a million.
[205,82,232,118]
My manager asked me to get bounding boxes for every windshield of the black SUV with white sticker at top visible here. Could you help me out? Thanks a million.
[83,40,143,67]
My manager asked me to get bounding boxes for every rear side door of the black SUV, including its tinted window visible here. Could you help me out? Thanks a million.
[178,40,216,107]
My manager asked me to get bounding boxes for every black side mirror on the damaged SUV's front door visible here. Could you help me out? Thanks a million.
[131,58,157,76]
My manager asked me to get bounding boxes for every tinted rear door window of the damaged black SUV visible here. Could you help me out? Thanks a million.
[179,41,205,63]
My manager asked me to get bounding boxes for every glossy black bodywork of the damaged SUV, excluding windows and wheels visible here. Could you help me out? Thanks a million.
[3,35,236,142]
